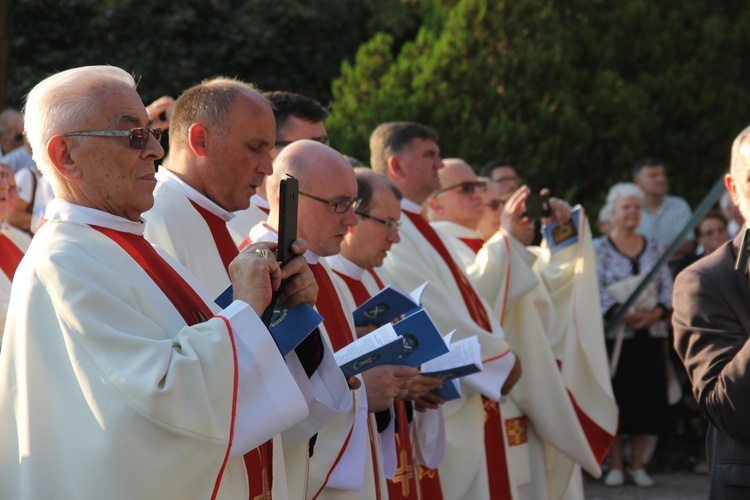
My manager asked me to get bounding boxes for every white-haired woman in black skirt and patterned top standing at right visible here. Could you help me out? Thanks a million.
[594,183,672,486]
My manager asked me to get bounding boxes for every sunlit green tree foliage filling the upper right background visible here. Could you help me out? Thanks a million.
[328,0,750,213]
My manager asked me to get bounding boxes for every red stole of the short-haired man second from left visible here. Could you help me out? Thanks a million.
[190,200,273,500]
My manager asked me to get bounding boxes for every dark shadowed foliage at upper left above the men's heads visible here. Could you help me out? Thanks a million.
[7,0,419,107]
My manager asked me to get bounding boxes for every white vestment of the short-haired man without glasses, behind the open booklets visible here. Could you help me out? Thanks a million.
[380,199,516,499]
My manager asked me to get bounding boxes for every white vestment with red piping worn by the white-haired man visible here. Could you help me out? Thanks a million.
[0,199,307,500]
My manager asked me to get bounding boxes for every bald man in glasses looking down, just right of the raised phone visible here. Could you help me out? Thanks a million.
[250,140,416,499]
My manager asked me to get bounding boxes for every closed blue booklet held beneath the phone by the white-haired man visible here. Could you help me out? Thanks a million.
[214,285,323,356]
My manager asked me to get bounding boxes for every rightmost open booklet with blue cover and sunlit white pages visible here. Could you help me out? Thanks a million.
[422,332,482,401]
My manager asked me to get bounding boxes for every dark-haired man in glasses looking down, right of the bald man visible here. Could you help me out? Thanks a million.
[326,167,445,500]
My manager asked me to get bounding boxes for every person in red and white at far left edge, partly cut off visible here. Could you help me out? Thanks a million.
[0,163,31,330]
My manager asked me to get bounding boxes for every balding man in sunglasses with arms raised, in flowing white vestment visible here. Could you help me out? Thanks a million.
[429,159,612,499]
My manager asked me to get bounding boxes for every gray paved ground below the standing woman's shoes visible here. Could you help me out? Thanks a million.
[584,472,708,500]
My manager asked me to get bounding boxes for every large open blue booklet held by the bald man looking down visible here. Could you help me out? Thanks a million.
[333,309,448,377]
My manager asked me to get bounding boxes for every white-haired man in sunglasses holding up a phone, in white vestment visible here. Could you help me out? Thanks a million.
[0,66,326,499]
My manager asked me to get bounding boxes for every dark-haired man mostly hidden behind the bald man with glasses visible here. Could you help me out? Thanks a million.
[227,91,328,245]
